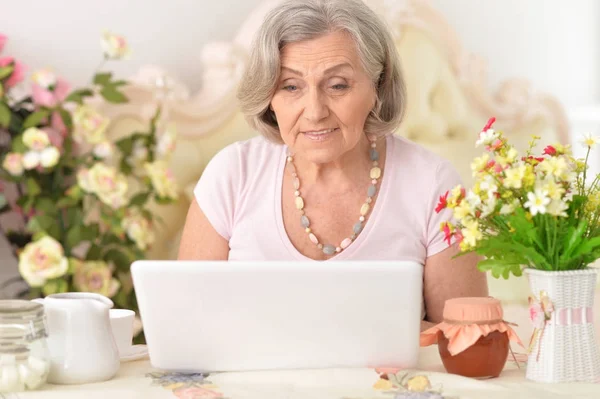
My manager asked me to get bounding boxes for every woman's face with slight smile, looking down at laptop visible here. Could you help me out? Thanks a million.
[271,32,375,164]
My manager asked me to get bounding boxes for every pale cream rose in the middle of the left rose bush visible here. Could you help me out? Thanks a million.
[77,162,128,209]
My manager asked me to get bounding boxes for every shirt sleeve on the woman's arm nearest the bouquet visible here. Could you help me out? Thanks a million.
[426,160,463,257]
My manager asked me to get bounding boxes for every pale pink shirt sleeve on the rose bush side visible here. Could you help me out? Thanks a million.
[194,143,243,241]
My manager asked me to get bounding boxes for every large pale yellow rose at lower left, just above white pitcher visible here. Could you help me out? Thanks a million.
[19,236,69,287]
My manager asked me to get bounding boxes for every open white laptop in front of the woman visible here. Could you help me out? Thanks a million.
[131,261,423,372]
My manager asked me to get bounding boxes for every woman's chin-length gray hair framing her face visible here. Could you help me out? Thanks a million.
[237,0,406,143]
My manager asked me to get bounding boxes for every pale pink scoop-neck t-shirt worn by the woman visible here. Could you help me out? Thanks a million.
[194,135,461,264]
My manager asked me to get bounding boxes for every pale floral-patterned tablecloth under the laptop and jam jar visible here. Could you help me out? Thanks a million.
[8,346,600,399]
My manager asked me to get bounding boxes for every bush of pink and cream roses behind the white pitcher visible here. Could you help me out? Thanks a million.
[0,33,178,334]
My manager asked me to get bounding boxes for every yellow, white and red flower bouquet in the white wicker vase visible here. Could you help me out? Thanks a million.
[436,118,600,278]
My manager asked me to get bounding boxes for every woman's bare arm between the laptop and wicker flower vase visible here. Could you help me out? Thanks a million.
[421,244,488,330]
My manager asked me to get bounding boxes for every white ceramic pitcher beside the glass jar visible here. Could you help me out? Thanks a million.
[34,292,120,384]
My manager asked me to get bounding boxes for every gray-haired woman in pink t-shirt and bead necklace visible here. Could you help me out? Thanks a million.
[179,0,487,327]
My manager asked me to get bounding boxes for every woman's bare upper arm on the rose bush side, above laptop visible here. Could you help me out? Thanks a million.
[177,199,229,260]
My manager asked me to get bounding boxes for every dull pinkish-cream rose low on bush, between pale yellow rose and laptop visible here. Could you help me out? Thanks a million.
[72,260,120,298]
